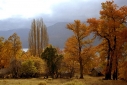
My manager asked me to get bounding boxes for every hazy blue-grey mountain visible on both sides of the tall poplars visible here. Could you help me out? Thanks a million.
[0,22,72,48]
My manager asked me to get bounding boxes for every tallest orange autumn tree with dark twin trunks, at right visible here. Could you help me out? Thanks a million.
[87,1,127,79]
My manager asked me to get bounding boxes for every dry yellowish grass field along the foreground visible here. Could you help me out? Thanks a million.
[0,76,127,85]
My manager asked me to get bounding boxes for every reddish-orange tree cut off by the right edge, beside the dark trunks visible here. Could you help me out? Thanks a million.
[119,26,127,81]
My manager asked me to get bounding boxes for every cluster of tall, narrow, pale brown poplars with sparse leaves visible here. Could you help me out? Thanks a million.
[28,19,48,57]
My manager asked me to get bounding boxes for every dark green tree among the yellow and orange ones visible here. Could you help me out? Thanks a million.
[41,45,63,77]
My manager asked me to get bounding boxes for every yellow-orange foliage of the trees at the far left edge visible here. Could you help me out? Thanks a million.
[0,33,22,67]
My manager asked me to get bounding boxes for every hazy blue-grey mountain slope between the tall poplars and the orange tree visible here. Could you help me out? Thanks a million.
[47,22,72,48]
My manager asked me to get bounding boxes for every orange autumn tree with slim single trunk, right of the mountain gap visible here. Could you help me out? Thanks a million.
[65,20,90,78]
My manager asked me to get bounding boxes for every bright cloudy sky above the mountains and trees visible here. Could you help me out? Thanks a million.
[0,0,127,30]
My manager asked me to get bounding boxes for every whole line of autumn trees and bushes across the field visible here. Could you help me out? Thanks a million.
[0,1,127,80]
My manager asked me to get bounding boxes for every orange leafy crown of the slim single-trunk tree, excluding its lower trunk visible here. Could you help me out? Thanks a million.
[65,20,91,56]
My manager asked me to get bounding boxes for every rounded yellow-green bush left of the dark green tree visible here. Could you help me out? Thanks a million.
[21,60,37,78]
